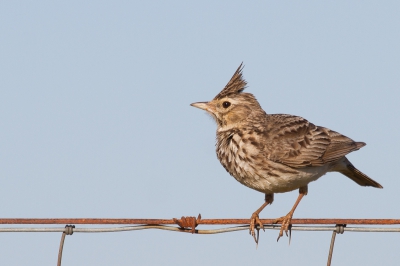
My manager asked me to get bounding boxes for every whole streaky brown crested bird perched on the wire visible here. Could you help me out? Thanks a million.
[191,62,383,244]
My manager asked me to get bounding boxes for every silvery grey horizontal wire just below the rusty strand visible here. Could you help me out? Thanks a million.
[0,225,400,234]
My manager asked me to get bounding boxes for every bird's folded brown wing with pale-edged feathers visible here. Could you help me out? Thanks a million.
[264,114,365,168]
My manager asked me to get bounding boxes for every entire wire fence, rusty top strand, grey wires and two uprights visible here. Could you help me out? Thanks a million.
[0,218,400,266]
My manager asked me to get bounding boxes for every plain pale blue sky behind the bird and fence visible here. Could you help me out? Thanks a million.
[0,1,400,265]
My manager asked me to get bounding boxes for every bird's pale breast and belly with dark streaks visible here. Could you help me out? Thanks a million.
[216,132,326,193]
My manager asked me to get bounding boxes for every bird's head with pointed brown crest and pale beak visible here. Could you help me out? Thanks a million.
[191,64,263,128]
